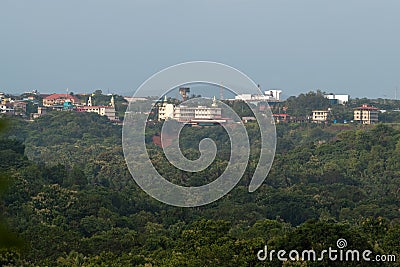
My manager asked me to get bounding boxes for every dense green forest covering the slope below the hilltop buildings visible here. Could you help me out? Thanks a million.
[0,110,400,266]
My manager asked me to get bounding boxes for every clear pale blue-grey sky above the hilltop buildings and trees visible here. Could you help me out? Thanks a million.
[0,0,400,98]
